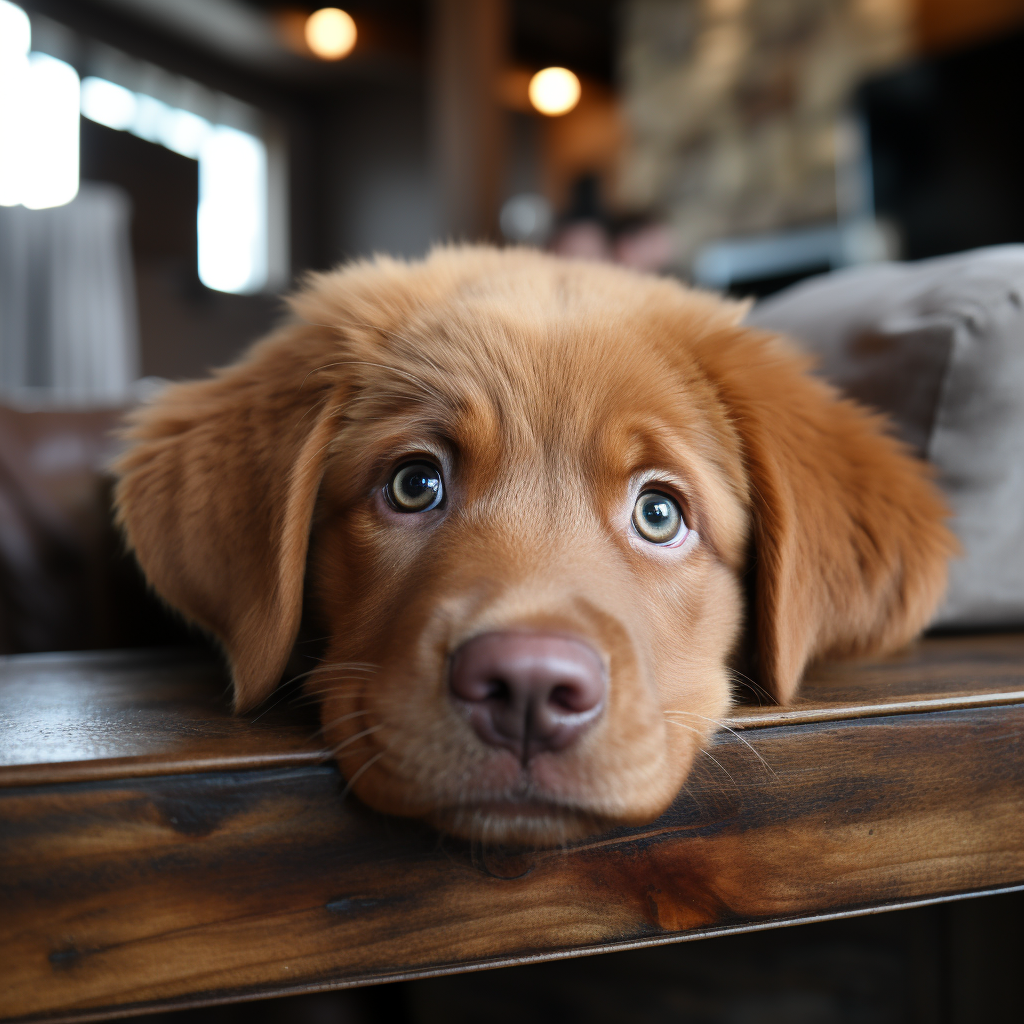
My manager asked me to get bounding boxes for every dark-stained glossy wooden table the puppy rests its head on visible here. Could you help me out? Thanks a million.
[0,634,1024,1020]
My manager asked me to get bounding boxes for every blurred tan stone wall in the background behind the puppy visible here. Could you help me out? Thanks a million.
[618,0,913,272]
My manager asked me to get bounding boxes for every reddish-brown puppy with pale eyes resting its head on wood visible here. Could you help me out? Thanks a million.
[118,248,953,843]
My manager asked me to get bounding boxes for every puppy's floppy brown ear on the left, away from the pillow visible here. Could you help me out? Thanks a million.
[116,326,337,710]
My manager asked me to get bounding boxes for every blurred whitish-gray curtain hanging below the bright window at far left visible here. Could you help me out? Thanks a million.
[0,181,139,406]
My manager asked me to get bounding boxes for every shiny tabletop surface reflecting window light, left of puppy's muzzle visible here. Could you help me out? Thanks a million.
[0,650,325,787]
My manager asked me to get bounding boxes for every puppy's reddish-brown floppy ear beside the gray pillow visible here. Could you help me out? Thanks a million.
[701,331,957,702]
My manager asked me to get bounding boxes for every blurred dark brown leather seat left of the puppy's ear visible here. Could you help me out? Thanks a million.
[0,406,194,653]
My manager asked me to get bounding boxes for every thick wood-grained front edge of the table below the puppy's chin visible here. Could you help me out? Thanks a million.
[0,700,1024,1019]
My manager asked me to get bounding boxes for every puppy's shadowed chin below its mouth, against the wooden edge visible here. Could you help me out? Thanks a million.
[428,799,617,849]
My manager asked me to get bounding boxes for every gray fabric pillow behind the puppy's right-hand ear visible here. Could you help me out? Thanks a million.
[748,245,1024,627]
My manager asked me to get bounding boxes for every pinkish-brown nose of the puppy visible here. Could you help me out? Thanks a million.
[450,633,607,764]
